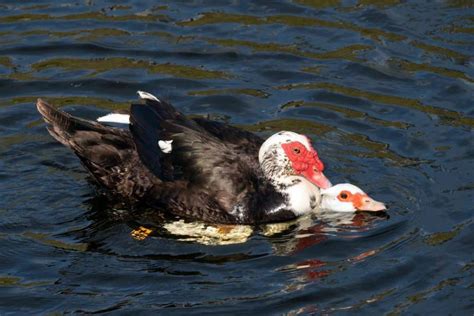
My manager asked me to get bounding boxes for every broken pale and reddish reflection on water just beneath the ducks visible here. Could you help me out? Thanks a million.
[73,196,389,255]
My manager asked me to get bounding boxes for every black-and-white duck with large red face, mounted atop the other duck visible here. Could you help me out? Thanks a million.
[37,92,330,224]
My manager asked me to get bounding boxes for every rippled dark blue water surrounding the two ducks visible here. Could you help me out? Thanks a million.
[0,0,474,315]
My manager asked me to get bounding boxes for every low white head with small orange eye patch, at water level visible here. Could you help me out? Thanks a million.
[320,183,387,212]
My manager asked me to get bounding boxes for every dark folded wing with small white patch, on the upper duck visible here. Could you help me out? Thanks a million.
[130,104,263,212]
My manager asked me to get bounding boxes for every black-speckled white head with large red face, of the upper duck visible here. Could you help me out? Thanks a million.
[258,131,331,188]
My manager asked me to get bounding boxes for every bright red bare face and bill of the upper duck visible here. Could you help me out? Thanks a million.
[281,141,331,189]
